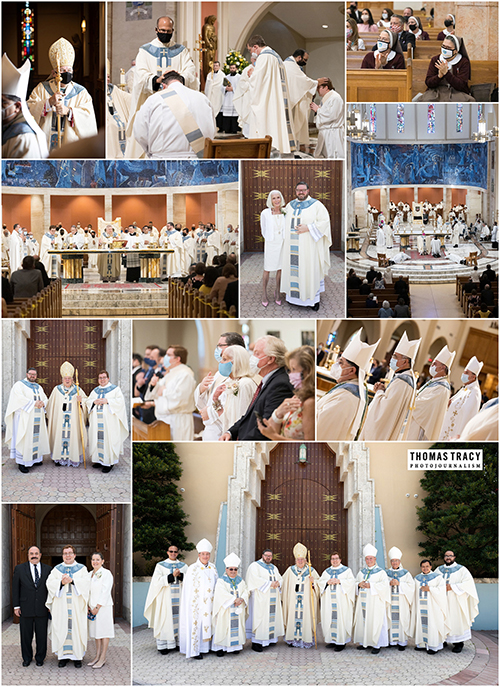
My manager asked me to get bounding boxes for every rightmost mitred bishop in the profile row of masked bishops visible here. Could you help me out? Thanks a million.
[439,356,484,441]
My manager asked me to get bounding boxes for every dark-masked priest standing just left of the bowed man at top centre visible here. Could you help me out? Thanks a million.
[283,48,318,147]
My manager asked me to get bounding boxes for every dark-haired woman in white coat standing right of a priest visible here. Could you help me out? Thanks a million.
[88,551,115,669]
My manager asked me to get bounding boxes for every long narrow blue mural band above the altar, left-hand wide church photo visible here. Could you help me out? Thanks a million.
[2,160,238,188]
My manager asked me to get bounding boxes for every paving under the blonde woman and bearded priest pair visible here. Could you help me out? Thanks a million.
[240,252,345,319]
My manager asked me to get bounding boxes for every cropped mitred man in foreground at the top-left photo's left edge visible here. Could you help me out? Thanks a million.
[2,53,49,160]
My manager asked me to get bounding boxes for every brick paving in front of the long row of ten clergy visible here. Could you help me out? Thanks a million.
[134,626,498,685]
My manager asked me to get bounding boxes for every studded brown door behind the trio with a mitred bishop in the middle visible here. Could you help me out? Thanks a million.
[27,320,106,396]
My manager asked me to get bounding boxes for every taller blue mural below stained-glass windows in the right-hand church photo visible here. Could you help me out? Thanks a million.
[351,143,488,189]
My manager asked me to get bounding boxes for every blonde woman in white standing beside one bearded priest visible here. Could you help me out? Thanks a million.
[260,191,286,308]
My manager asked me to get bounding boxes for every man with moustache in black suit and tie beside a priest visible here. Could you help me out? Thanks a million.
[12,546,51,668]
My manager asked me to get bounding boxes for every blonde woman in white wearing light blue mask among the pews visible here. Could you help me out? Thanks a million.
[207,346,257,434]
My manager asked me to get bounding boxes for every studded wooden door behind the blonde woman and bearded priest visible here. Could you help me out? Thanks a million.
[241,160,343,252]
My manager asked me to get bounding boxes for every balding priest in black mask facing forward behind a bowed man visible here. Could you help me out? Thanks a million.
[125,16,199,159]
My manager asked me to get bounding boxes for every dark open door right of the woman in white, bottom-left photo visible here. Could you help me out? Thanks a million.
[96,504,123,617]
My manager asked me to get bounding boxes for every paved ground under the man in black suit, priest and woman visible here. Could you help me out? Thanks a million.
[2,618,132,685]
